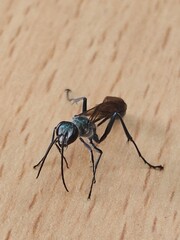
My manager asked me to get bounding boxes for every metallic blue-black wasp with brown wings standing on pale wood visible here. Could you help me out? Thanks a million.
[34,89,163,199]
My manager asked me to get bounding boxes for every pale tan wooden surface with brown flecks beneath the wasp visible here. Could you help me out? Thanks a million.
[0,0,180,240]
